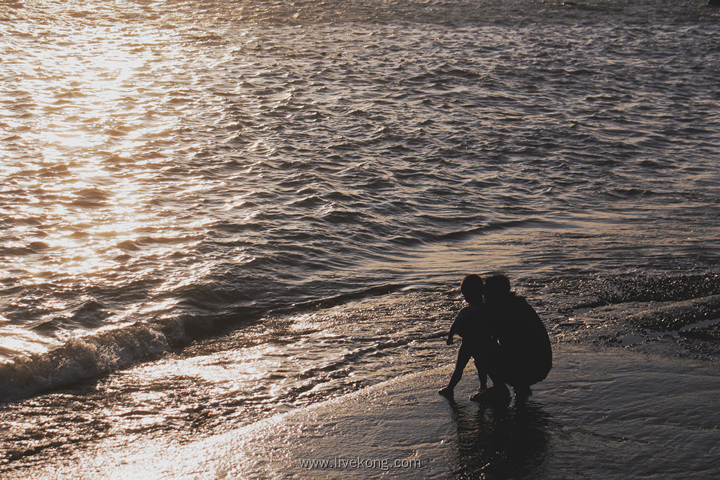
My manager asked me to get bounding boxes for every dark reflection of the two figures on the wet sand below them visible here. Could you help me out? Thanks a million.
[450,399,550,480]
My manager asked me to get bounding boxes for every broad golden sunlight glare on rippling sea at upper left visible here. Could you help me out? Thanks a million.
[0,9,228,358]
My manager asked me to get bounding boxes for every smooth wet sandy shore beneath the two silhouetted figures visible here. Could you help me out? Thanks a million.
[7,346,720,479]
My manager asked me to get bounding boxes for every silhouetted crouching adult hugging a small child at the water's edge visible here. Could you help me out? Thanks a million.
[474,274,552,400]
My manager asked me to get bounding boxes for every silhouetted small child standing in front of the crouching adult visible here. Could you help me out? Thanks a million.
[438,275,496,399]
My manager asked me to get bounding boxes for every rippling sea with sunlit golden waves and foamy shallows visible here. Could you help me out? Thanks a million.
[0,0,720,471]
